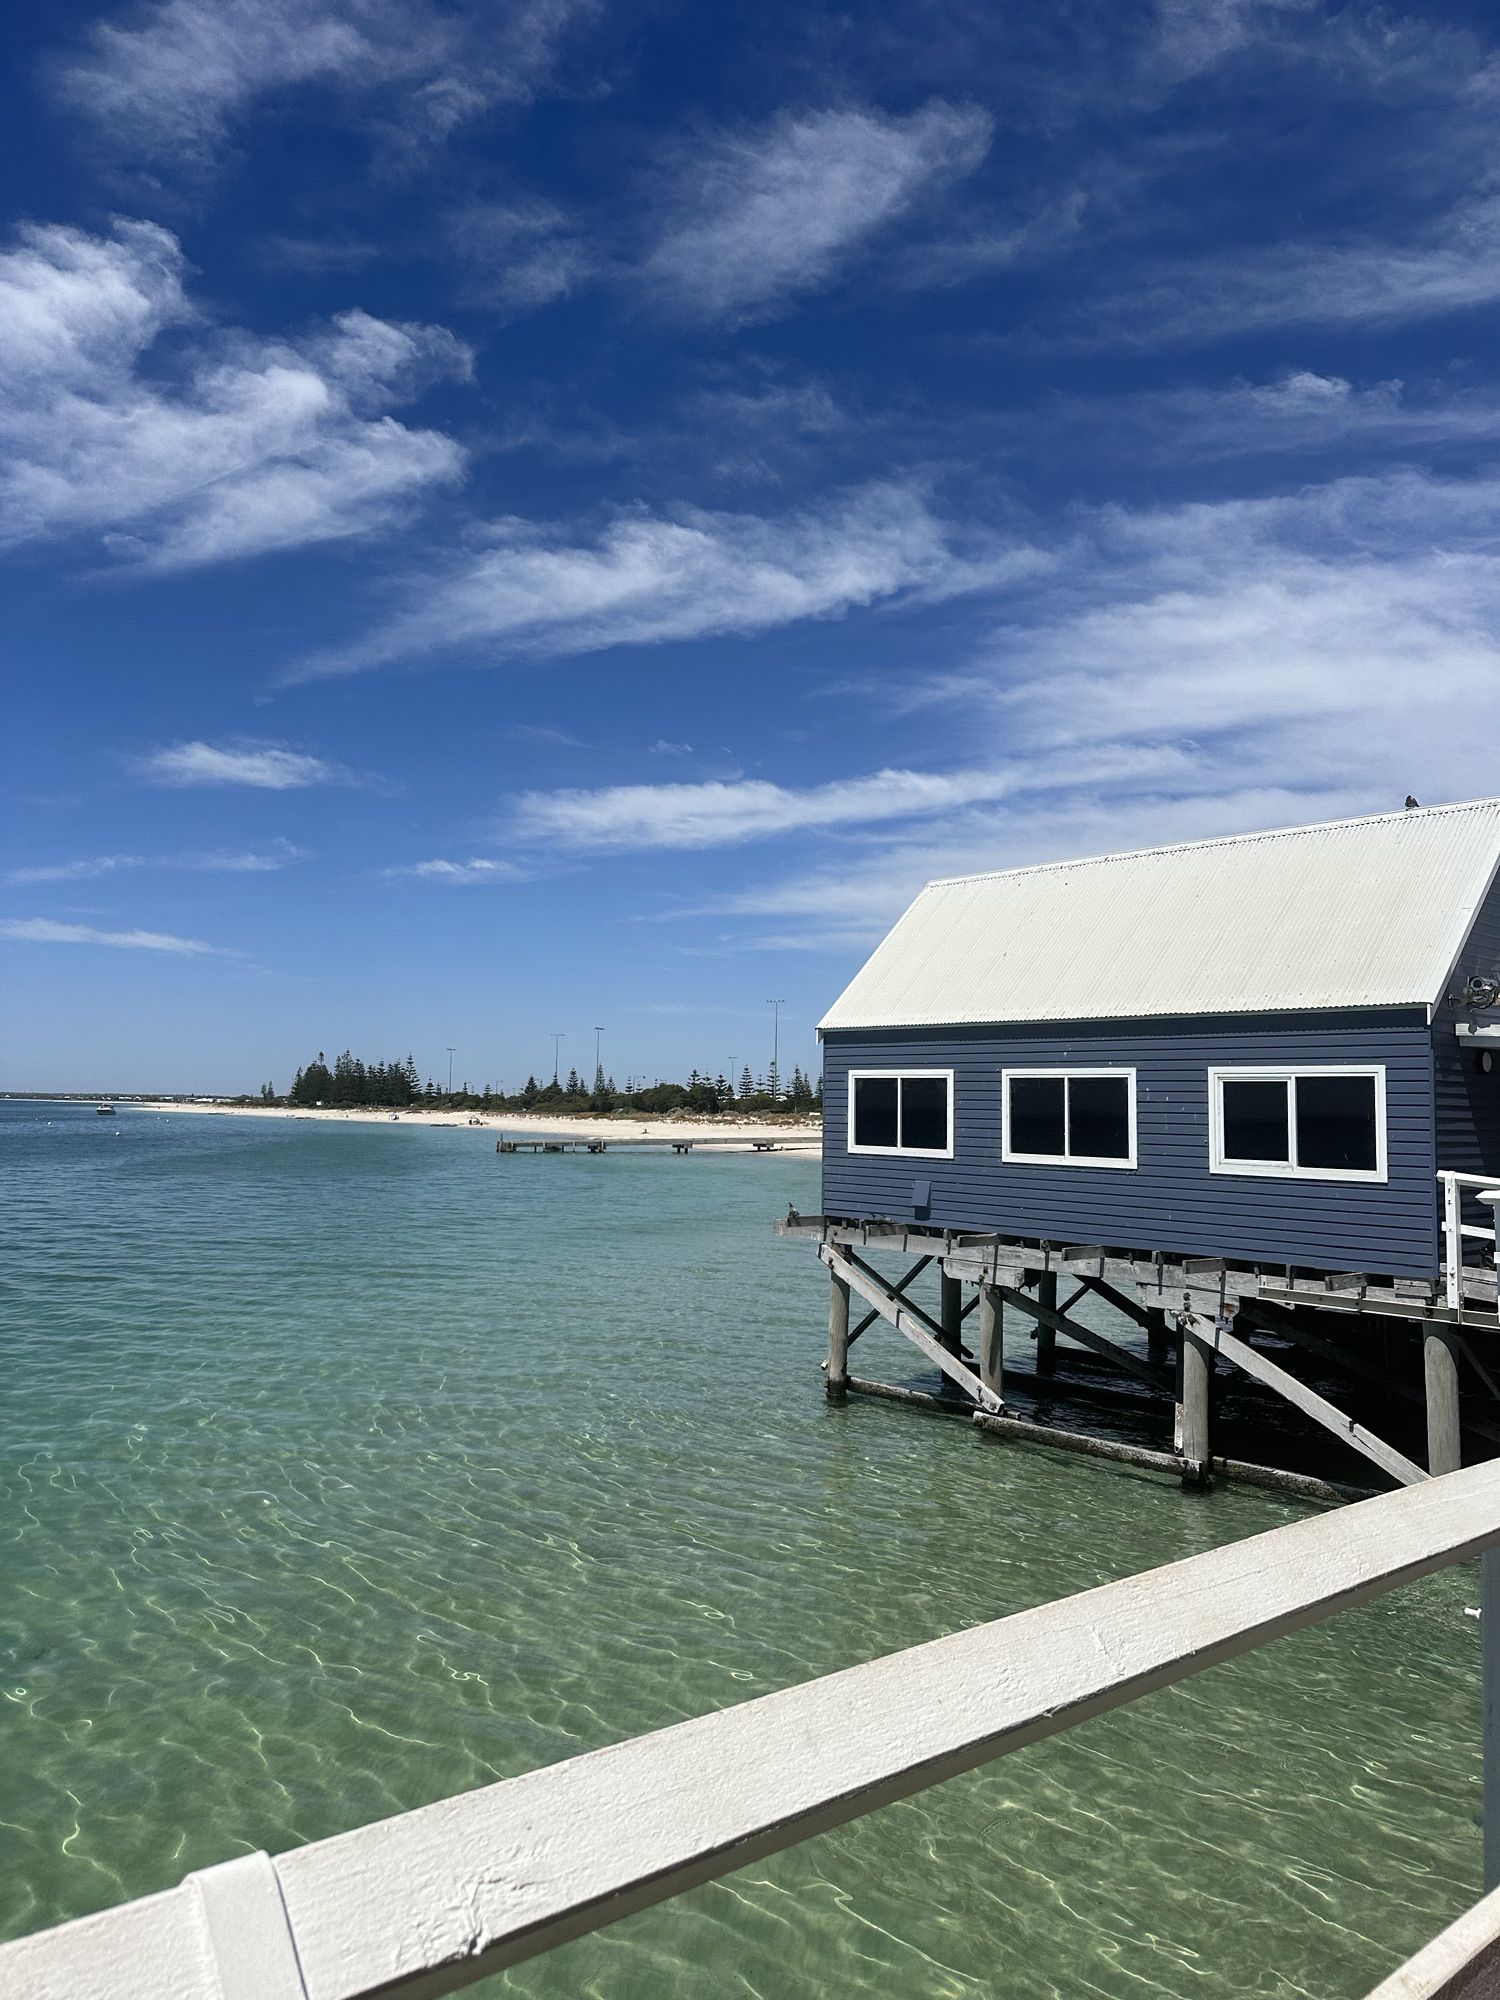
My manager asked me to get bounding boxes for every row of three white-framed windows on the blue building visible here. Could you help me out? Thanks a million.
[848,1066,1386,1180]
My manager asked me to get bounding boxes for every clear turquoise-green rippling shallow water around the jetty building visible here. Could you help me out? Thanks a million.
[0,1104,1480,2000]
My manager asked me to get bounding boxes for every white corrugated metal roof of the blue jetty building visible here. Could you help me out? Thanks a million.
[820,798,1500,1028]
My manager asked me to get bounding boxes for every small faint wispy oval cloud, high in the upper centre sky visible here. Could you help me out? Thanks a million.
[642,100,994,322]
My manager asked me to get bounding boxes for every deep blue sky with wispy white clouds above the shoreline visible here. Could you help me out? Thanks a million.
[0,0,1500,1092]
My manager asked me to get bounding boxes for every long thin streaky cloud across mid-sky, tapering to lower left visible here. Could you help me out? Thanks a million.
[306,484,1042,680]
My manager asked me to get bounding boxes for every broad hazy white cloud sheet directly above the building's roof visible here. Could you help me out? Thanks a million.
[572,472,1500,950]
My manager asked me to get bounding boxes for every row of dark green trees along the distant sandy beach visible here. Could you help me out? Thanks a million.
[260,1050,822,1116]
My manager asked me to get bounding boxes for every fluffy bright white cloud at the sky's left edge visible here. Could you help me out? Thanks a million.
[0,222,468,568]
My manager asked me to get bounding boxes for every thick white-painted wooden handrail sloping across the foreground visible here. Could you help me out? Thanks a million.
[0,1460,1500,2000]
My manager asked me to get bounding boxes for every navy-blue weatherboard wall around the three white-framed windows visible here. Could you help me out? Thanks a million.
[822,1010,1448,1278]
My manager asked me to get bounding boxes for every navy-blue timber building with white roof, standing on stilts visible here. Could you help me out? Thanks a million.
[820,800,1500,1280]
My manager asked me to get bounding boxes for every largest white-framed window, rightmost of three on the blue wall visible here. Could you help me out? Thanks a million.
[1208,1066,1386,1180]
